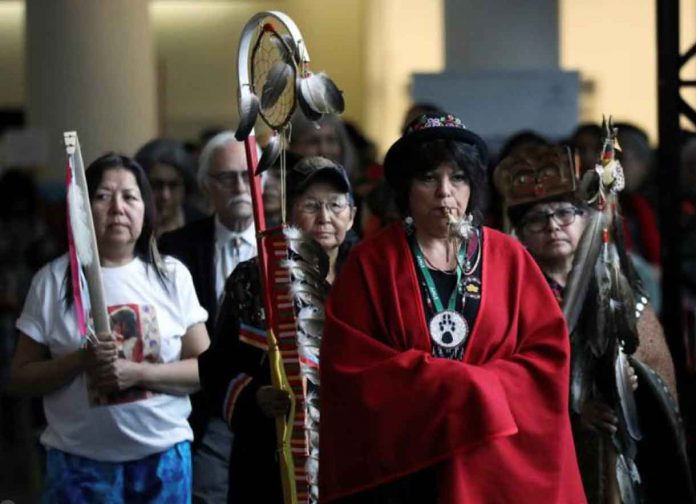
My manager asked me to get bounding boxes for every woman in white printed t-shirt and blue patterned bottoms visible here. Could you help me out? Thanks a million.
[11,154,209,503]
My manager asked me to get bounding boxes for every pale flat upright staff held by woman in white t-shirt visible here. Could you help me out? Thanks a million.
[63,131,111,343]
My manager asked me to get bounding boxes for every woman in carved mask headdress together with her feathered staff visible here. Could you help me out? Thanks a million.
[494,142,693,504]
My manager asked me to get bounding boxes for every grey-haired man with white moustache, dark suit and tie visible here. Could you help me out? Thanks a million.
[159,131,256,503]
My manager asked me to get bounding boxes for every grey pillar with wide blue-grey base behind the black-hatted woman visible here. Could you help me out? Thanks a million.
[411,0,580,152]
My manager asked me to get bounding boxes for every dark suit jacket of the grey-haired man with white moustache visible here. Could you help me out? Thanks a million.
[158,217,219,444]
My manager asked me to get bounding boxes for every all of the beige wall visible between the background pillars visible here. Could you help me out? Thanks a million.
[0,0,696,151]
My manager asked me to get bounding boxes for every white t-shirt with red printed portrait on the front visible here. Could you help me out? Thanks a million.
[17,254,207,462]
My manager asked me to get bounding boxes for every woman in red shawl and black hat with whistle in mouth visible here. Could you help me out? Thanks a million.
[320,114,585,504]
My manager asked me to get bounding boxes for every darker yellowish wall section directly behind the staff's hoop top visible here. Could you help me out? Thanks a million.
[150,0,365,142]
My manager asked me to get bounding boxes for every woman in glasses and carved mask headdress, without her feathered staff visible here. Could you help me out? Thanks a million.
[494,146,691,504]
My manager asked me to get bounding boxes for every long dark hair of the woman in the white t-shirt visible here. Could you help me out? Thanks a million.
[63,152,165,307]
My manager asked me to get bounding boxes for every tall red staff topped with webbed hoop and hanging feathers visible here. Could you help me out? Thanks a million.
[236,12,344,504]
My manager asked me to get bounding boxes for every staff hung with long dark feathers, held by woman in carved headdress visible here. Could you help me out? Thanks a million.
[563,117,641,504]
